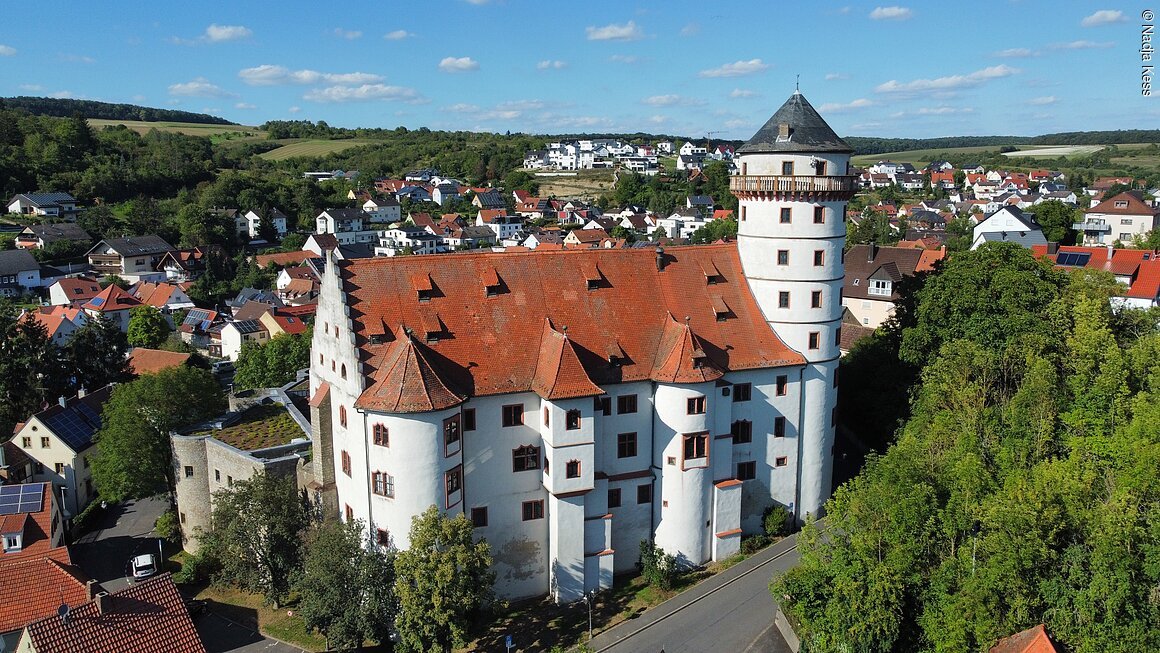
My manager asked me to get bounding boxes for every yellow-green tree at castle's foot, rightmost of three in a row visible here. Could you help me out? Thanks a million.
[394,506,495,653]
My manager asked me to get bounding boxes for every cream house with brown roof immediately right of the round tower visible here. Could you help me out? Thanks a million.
[842,245,944,328]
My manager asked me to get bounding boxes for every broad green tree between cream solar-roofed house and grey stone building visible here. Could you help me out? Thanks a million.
[93,365,226,501]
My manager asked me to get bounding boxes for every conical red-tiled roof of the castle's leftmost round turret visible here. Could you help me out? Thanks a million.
[355,326,467,413]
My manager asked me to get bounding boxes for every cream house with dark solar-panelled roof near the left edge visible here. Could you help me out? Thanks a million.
[12,385,113,520]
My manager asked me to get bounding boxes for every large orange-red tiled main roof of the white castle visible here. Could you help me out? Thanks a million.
[338,242,804,403]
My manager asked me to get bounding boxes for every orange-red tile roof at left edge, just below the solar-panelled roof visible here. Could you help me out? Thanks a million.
[0,546,88,632]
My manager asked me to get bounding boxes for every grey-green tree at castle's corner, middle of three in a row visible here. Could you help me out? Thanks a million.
[296,521,398,650]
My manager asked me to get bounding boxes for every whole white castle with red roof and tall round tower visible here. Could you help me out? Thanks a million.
[310,93,856,602]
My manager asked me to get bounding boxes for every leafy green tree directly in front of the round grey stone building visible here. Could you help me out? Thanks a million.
[195,472,313,608]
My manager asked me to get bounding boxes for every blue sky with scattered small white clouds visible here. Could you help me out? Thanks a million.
[0,0,1160,139]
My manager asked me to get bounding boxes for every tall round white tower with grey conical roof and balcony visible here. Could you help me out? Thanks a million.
[730,92,857,517]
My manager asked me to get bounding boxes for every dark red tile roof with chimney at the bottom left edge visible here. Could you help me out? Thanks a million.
[26,574,205,653]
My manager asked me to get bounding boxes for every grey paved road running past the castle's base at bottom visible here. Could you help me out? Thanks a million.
[592,537,798,653]
